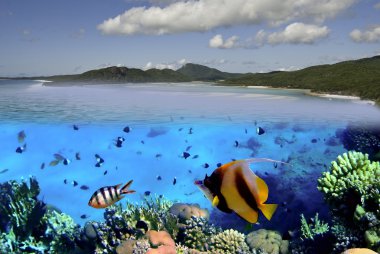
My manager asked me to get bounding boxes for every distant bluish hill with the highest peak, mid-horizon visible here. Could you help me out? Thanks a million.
[177,63,242,81]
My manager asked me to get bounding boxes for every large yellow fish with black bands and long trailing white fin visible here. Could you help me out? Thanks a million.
[195,158,277,223]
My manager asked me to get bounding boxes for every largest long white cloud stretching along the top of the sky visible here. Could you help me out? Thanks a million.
[98,0,357,35]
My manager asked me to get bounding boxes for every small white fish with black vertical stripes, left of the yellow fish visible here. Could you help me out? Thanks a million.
[88,180,135,208]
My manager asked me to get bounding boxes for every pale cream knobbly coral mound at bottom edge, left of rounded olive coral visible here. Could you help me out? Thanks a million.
[210,229,249,254]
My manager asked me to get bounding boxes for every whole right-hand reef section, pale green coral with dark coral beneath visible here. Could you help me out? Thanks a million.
[318,151,380,253]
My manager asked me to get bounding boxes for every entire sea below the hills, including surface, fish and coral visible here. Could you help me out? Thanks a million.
[0,80,380,254]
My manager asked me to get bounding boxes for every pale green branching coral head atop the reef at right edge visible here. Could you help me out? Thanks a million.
[318,151,380,216]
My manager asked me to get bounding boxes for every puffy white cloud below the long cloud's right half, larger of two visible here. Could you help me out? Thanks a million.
[267,23,330,44]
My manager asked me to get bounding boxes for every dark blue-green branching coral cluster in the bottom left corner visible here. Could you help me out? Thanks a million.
[0,177,79,253]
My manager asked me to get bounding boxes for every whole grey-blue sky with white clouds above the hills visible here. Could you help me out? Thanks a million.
[0,0,380,77]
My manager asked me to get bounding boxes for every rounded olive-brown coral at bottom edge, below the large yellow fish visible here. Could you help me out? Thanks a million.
[246,229,289,254]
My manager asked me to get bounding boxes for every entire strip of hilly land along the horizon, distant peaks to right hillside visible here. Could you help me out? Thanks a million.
[3,56,380,105]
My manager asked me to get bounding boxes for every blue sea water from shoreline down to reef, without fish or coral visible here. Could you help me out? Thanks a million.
[0,80,380,231]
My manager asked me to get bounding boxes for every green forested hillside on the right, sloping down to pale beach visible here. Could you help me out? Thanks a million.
[221,56,380,103]
